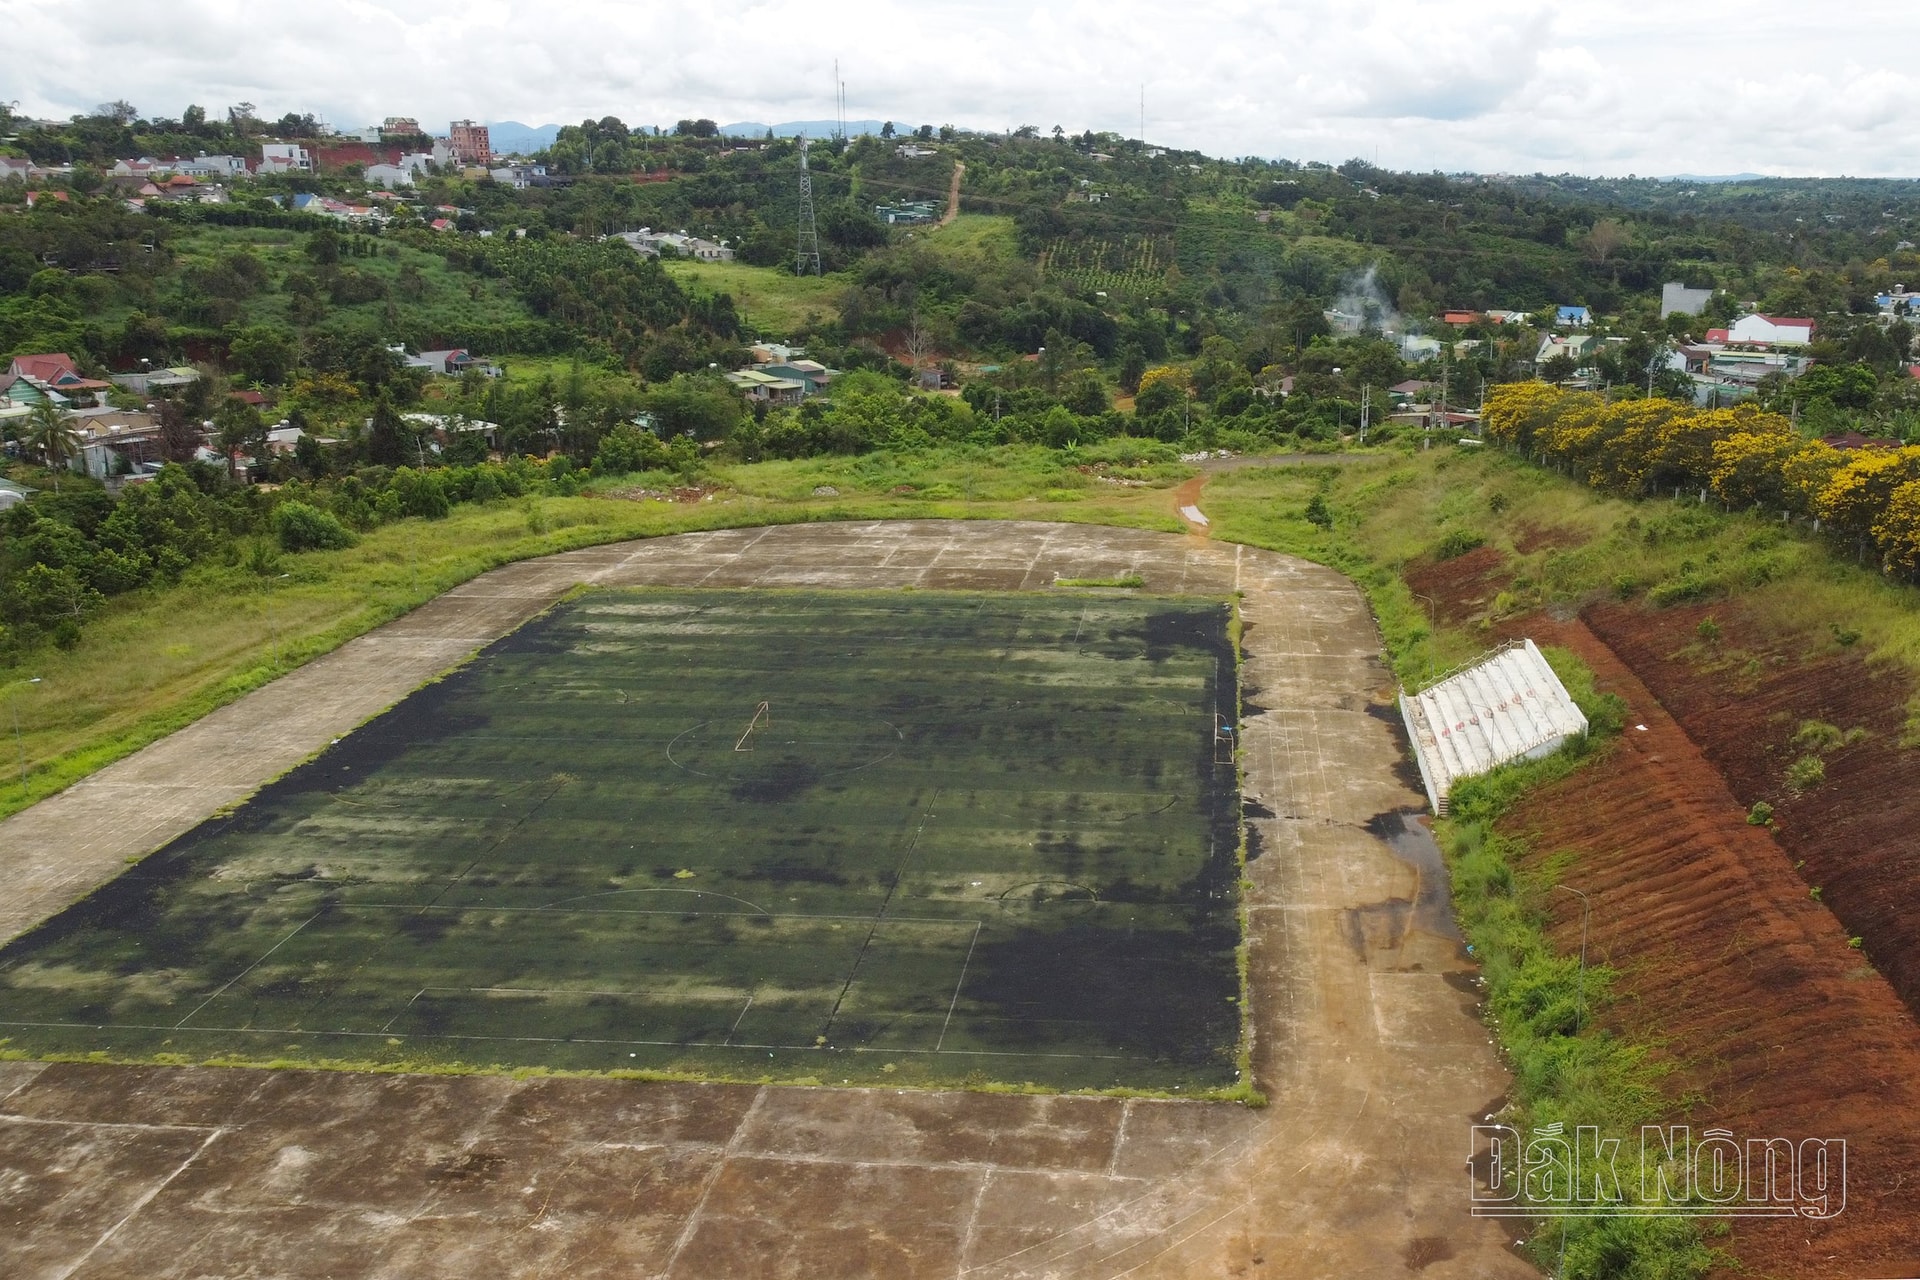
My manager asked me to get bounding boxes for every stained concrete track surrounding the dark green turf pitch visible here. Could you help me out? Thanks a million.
[0,520,1536,1280]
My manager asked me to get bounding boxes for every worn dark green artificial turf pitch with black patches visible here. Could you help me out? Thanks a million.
[0,589,1240,1092]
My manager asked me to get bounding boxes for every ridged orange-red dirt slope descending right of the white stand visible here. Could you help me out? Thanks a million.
[1507,612,1920,1276]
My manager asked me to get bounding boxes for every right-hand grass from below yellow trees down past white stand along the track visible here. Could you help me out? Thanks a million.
[1206,451,1920,1276]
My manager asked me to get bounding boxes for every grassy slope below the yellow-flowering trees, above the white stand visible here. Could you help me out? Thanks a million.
[1208,451,1920,710]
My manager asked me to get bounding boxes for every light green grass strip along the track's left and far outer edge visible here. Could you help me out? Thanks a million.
[0,449,1187,816]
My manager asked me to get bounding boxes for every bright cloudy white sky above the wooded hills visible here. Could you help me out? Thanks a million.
[15,0,1920,177]
